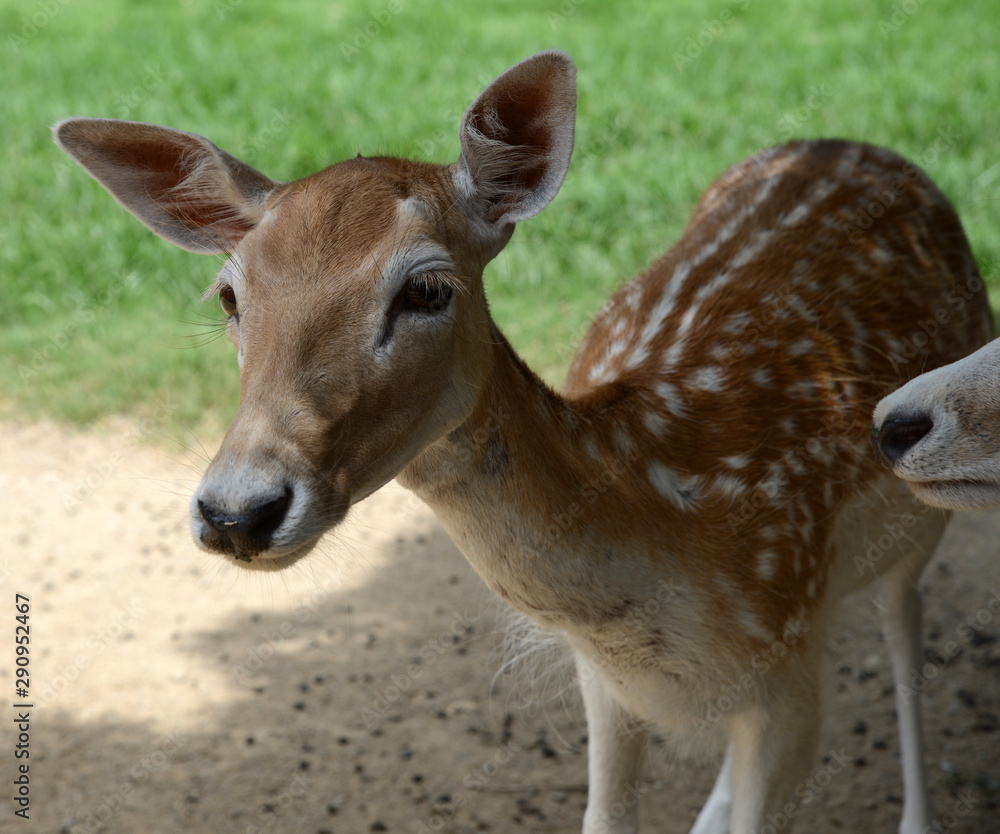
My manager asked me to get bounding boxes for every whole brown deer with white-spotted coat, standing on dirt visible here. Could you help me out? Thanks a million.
[54,50,991,834]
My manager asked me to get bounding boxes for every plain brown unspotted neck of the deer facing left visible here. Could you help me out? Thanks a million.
[399,326,634,626]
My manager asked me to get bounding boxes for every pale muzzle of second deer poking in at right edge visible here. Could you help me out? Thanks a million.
[872,334,1000,510]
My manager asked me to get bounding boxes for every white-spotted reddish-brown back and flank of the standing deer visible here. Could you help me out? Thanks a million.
[565,141,992,634]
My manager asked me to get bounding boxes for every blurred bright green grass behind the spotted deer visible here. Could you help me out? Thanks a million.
[0,0,1000,432]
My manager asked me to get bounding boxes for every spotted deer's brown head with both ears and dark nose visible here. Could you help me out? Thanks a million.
[54,51,576,570]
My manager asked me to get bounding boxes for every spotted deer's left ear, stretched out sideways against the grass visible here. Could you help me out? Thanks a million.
[52,119,279,254]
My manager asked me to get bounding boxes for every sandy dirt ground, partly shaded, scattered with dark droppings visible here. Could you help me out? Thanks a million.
[0,416,1000,834]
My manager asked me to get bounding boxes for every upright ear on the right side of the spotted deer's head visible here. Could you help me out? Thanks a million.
[455,50,576,233]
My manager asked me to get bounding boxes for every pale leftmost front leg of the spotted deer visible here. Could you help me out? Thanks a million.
[577,656,649,834]
